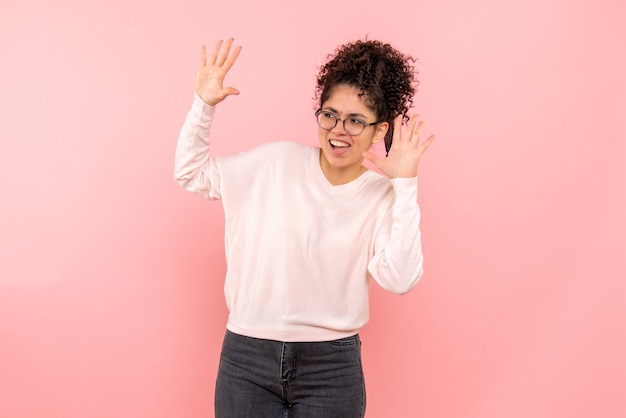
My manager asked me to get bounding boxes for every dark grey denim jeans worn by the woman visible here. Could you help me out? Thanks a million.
[215,331,365,418]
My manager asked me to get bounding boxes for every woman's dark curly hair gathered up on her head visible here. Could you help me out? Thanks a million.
[315,39,419,152]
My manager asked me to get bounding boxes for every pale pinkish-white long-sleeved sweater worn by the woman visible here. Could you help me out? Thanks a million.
[174,95,423,341]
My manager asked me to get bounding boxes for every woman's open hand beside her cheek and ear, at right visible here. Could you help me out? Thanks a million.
[363,115,435,179]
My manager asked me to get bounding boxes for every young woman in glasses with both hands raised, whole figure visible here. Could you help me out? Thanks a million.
[175,39,434,418]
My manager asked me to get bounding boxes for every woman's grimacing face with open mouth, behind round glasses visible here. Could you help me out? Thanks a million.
[318,85,389,185]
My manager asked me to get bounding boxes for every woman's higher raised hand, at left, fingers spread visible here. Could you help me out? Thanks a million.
[196,38,241,106]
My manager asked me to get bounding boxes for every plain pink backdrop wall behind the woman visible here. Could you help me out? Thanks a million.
[0,0,626,418]
